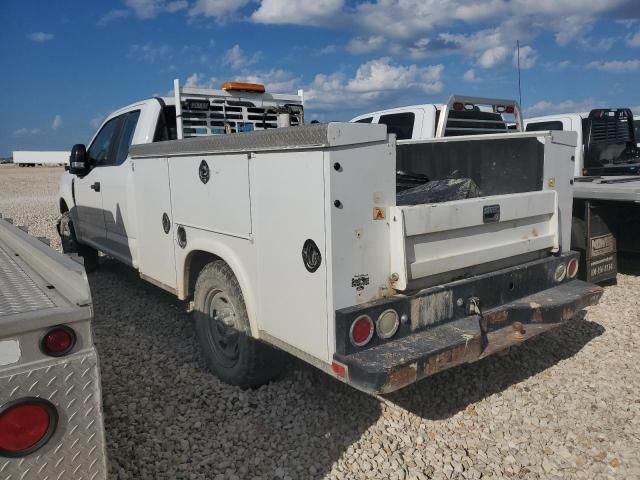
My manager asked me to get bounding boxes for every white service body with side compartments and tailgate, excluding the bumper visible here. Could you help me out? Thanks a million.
[132,124,575,368]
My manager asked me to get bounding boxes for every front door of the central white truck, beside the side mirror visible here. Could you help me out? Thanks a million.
[74,117,121,249]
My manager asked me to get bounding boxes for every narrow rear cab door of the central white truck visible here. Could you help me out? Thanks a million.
[101,110,140,265]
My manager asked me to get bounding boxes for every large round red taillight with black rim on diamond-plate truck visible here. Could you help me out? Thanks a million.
[0,398,58,457]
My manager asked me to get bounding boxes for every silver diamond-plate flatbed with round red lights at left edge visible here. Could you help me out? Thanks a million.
[0,216,107,480]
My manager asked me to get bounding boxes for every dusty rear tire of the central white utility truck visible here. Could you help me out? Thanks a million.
[193,260,285,388]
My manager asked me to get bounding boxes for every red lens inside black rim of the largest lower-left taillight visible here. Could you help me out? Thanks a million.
[0,403,50,454]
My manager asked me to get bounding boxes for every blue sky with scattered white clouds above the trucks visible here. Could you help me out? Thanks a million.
[0,0,640,156]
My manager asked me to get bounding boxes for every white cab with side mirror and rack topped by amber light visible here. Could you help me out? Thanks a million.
[58,81,304,270]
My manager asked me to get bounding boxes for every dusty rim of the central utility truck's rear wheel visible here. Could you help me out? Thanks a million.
[205,290,240,368]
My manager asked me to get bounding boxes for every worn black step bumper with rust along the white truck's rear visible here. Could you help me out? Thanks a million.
[335,280,603,393]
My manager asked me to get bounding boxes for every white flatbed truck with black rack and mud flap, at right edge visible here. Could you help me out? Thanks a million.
[525,108,640,282]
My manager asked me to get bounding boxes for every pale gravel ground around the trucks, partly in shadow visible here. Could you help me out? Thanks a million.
[0,167,640,480]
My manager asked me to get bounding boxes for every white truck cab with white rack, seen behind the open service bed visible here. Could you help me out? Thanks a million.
[351,95,522,141]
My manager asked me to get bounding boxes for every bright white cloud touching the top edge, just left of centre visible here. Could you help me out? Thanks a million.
[251,0,344,25]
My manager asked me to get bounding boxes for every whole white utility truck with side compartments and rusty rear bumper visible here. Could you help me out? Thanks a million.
[60,80,602,392]
